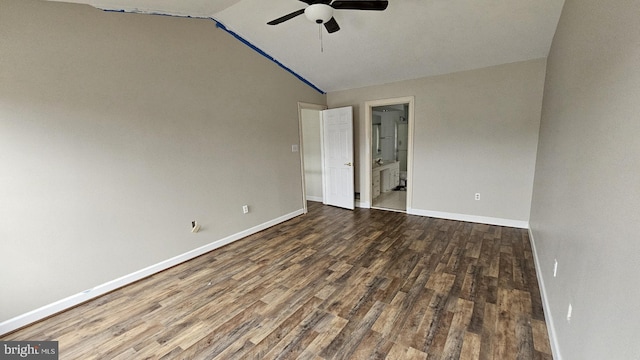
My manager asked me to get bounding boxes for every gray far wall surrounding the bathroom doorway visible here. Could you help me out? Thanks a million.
[327,59,545,222]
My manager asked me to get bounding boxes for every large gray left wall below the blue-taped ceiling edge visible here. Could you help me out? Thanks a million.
[0,0,325,322]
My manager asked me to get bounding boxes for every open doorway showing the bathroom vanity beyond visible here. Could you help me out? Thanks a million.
[365,97,413,212]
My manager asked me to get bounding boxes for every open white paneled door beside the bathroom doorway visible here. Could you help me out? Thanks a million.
[322,106,355,210]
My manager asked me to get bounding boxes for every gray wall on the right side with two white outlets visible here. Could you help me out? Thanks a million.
[531,0,640,360]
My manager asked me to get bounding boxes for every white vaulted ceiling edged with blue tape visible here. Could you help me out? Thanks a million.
[46,0,564,92]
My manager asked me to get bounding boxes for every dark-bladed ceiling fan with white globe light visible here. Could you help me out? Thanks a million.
[267,0,389,33]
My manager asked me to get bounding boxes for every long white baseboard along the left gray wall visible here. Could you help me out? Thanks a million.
[0,209,303,335]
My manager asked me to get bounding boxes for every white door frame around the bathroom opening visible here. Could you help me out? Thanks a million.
[364,96,415,214]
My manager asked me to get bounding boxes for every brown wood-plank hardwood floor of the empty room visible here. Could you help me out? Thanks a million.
[1,203,551,359]
